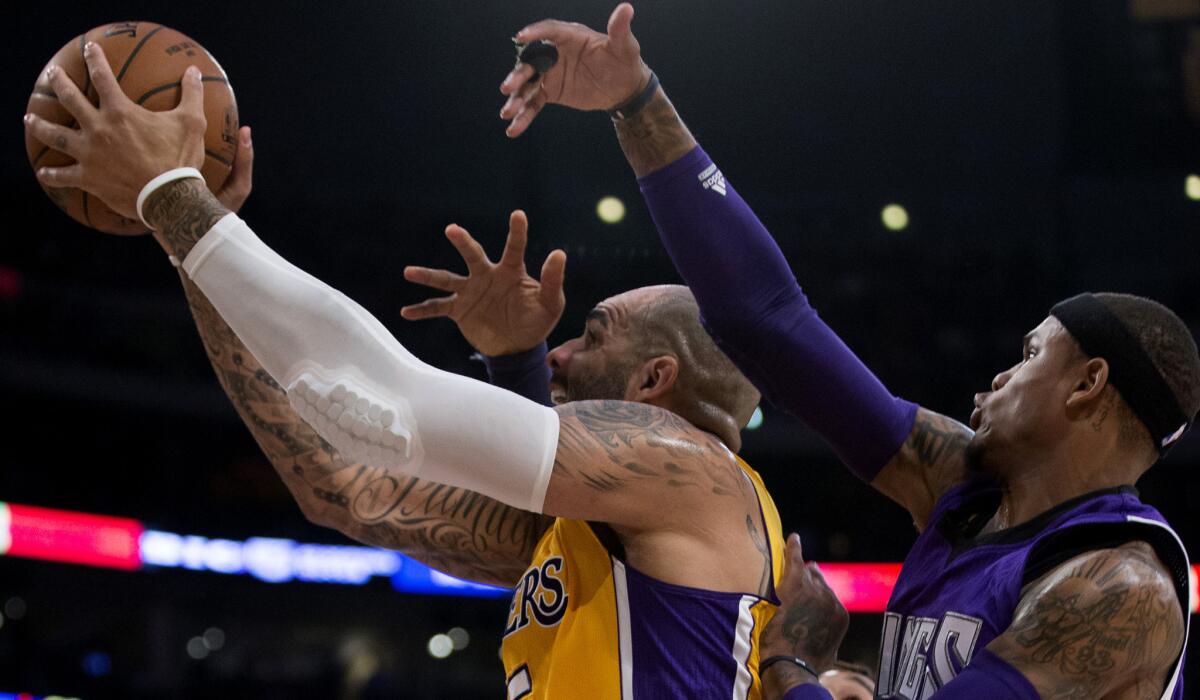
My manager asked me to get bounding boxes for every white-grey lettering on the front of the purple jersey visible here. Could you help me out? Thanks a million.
[877,612,983,700]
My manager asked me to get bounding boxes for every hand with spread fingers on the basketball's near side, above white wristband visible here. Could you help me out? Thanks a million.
[25,43,206,225]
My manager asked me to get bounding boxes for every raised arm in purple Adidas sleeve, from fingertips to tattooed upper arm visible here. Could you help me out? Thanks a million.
[500,4,971,525]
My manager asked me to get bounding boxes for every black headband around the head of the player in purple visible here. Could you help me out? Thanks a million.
[1050,292,1190,454]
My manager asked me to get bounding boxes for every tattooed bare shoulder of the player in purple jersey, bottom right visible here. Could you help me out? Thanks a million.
[988,543,1183,700]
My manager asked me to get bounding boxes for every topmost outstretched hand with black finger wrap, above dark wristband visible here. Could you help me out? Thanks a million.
[500,2,650,138]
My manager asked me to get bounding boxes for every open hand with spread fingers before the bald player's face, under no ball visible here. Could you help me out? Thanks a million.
[401,210,566,355]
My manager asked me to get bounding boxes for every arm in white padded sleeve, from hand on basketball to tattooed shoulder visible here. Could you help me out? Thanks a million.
[30,44,752,549]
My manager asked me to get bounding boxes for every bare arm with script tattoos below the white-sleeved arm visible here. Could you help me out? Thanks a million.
[181,275,552,586]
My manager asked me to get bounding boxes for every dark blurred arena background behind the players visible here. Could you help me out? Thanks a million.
[0,0,1200,699]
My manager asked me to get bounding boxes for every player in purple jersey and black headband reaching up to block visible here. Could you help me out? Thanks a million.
[500,4,1200,700]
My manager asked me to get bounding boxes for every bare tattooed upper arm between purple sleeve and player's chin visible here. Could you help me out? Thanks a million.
[871,408,974,530]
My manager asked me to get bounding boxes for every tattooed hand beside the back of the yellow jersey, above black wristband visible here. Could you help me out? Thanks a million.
[761,533,850,672]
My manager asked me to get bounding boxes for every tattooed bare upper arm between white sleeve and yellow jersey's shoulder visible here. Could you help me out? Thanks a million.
[546,401,754,526]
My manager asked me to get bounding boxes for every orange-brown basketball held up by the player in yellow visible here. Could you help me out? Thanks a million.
[25,22,238,235]
